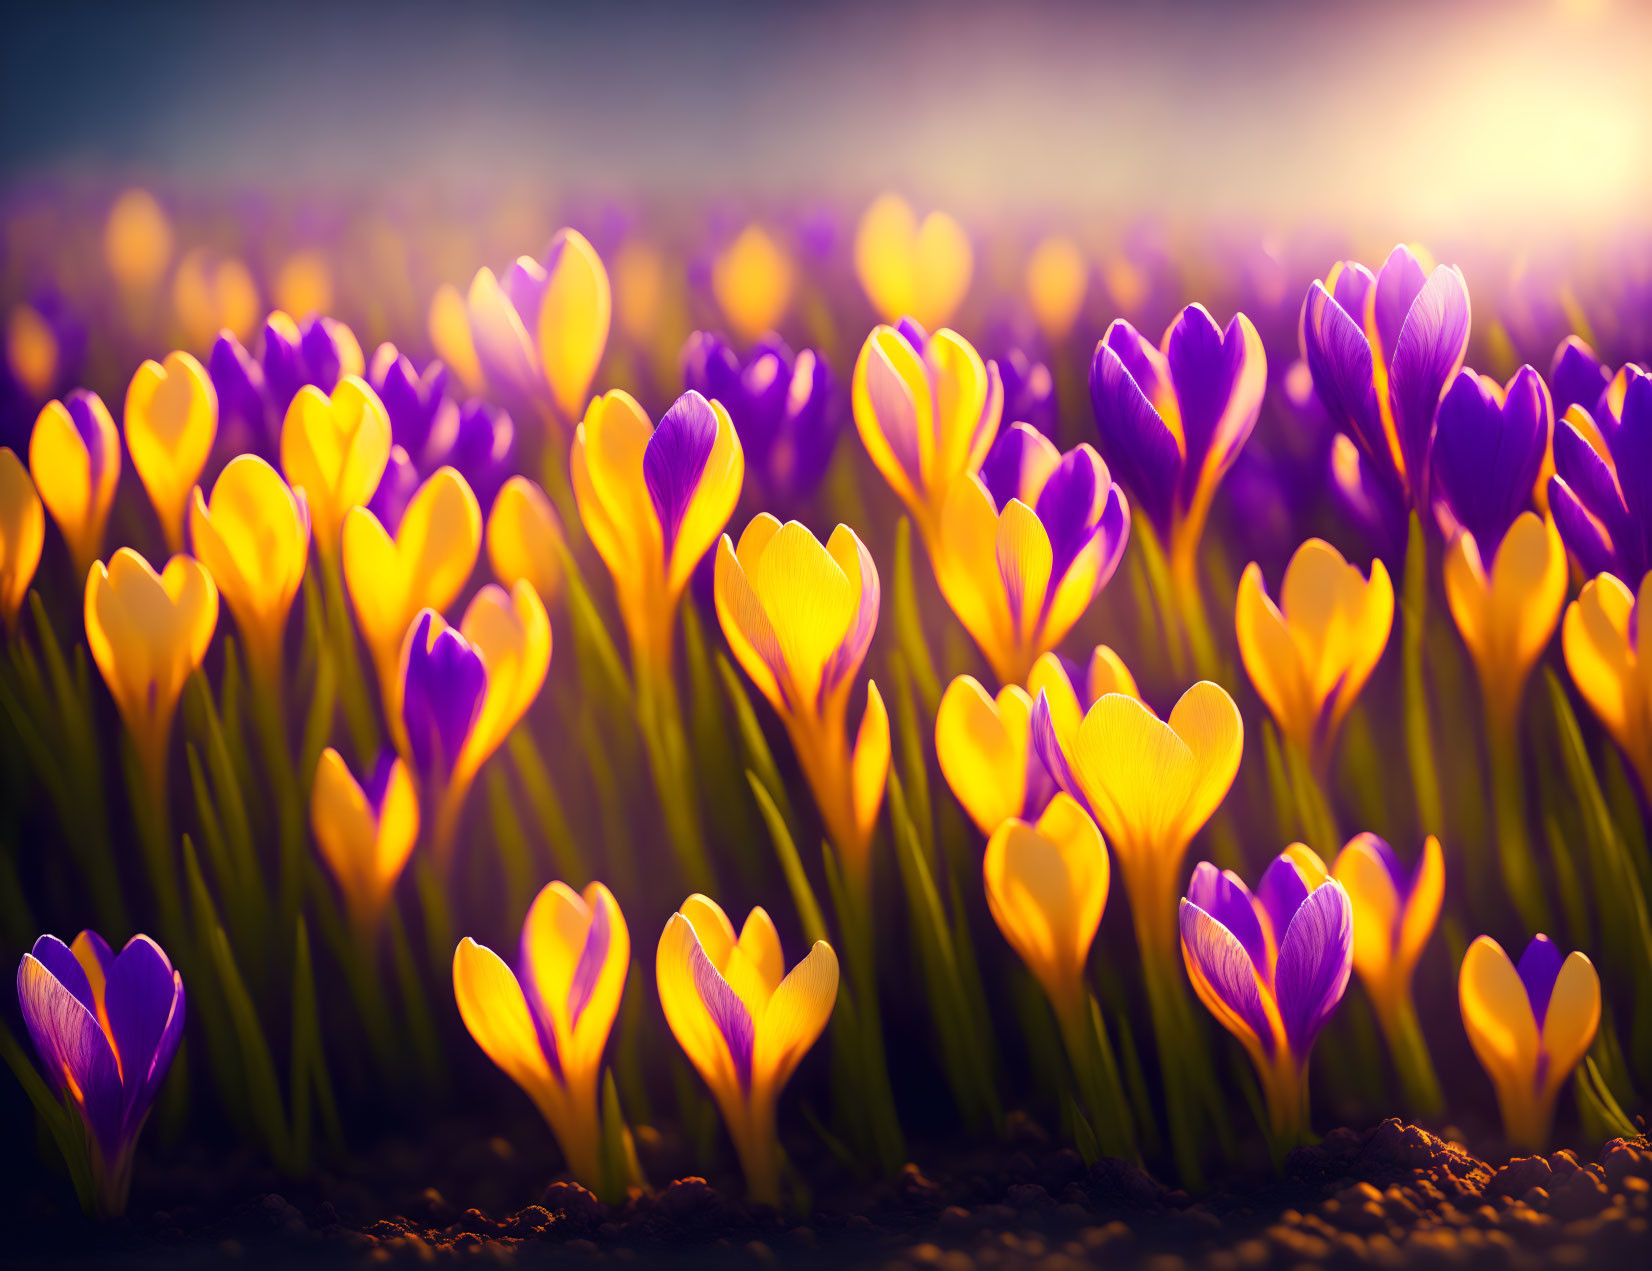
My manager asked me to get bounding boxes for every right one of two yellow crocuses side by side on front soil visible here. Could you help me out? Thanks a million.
[654,894,838,1205]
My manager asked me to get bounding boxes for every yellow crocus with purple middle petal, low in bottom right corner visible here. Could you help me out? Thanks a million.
[1457,935,1601,1152]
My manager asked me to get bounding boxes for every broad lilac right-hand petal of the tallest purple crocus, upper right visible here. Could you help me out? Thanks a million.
[1388,264,1469,506]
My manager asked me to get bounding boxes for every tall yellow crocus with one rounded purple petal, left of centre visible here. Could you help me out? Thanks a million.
[573,390,745,681]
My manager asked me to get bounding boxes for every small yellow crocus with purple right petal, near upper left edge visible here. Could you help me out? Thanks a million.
[28,388,121,574]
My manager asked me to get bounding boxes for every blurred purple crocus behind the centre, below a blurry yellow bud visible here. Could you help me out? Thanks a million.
[682,331,843,504]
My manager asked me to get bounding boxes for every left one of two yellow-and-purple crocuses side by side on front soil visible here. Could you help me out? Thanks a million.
[453,883,631,1192]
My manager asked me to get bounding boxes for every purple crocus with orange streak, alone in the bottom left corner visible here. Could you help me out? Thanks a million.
[17,931,183,1216]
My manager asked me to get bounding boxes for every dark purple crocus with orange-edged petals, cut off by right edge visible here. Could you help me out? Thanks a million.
[1550,365,1652,587]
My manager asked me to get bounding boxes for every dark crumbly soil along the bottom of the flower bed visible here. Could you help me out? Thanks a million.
[0,1121,1652,1271]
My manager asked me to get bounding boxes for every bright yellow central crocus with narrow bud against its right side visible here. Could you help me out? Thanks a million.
[715,512,889,886]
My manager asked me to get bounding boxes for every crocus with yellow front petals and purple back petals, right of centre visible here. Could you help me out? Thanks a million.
[930,423,1130,684]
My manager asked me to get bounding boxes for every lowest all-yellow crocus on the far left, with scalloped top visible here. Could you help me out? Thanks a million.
[86,547,218,790]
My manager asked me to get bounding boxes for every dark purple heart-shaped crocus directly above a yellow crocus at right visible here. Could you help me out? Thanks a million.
[1434,367,1555,548]
